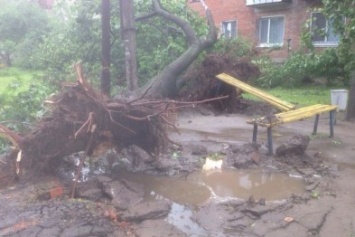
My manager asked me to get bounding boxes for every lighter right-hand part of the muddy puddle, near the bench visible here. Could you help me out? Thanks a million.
[188,170,304,200]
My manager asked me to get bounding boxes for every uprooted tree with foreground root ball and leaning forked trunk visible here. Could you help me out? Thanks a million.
[0,0,256,186]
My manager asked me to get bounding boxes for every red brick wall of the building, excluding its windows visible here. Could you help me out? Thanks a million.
[188,0,322,61]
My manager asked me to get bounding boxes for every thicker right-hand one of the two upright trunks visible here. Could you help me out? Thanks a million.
[120,0,138,90]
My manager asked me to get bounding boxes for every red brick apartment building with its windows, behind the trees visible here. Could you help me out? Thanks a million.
[188,0,339,62]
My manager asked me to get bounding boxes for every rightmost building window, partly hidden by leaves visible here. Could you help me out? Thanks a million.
[311,13,339,46]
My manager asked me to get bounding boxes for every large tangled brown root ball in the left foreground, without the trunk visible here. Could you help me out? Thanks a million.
[0,64,225,186]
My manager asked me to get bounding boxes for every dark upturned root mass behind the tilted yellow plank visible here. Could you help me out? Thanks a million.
[179,54,260,112]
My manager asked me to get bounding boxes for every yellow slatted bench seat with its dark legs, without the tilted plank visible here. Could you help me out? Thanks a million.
[247,104,337,155]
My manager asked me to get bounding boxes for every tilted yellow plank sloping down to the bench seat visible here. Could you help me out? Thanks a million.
[216,73,296,111]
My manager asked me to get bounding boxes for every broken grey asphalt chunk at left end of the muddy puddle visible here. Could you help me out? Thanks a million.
[102,177,144,210]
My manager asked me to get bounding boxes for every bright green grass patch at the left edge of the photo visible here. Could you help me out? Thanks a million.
[0,67,43,96]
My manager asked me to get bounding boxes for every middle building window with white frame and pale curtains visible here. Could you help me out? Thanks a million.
[259,17,285,47]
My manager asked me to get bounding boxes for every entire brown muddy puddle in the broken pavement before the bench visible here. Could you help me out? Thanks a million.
[119,170,305,207]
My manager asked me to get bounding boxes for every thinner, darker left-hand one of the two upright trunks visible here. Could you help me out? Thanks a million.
[101,0,111,96]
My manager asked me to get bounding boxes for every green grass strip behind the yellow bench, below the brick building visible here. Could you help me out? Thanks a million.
[243,86,350,107]
